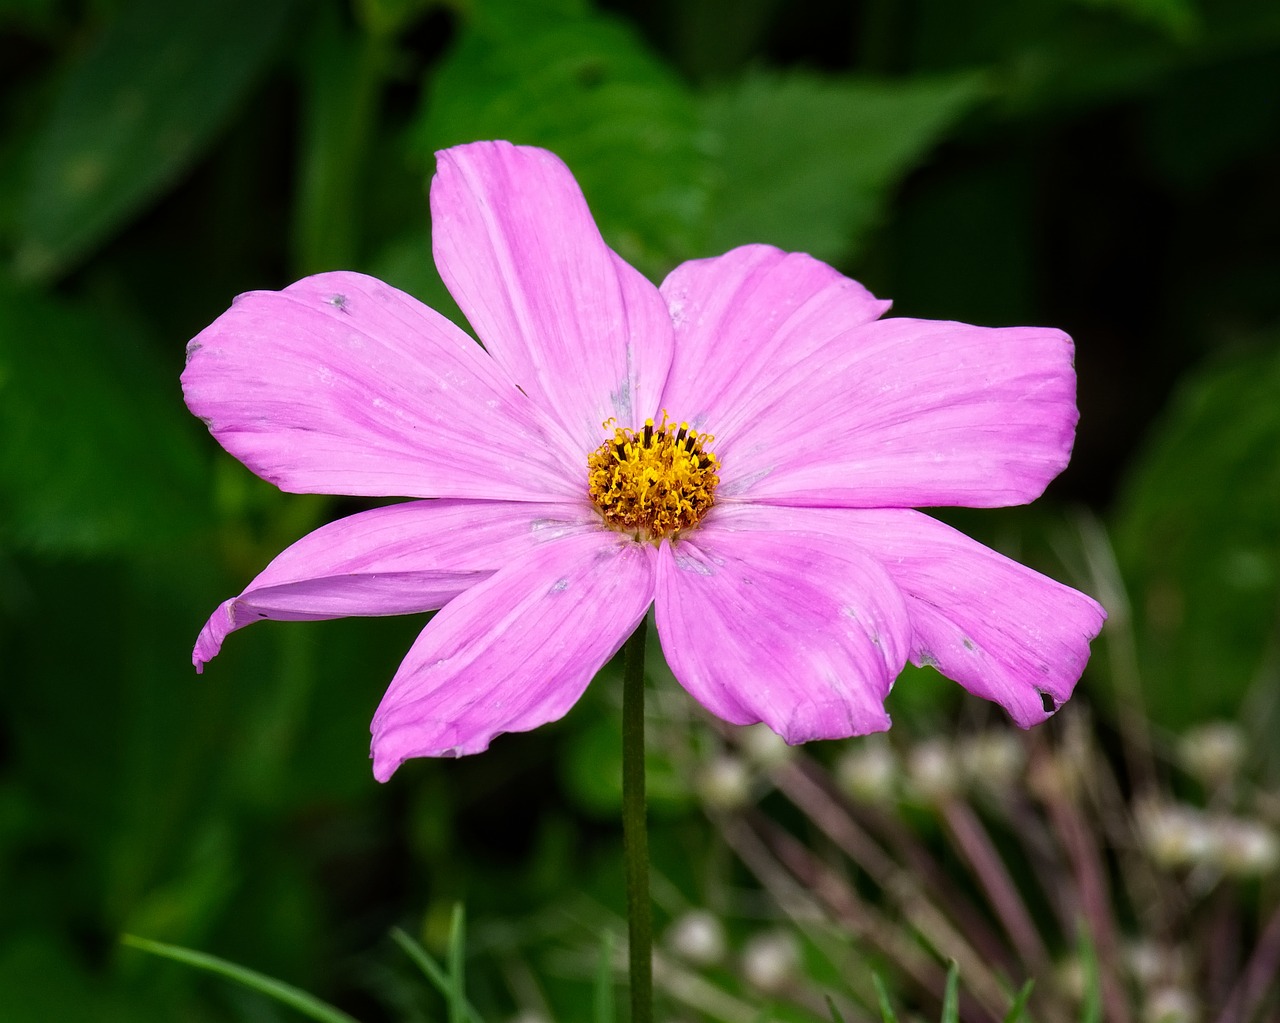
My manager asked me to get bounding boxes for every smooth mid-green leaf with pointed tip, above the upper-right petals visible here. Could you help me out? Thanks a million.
[703,74,984,261]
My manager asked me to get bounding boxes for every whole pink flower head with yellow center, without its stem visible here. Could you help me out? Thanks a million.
[183,142,1105,781]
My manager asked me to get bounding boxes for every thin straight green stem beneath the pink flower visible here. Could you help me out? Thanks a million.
[622,618,653,1023]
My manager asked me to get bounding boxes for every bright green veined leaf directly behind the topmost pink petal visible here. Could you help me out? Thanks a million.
[419,4,709,277]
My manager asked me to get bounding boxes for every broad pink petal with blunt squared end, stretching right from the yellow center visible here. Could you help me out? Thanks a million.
[709,319,1079,508]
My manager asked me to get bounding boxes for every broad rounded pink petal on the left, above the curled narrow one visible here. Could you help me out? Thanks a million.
[182,273,582,501]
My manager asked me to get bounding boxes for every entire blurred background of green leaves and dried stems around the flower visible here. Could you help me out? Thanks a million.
[0,0,1280,1023]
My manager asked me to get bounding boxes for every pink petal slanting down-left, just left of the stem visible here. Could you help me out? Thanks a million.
[372,531,657,781]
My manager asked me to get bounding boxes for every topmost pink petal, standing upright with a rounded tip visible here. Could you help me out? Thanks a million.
[431,142,672,458]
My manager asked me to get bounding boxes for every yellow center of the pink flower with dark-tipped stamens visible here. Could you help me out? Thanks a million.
[586,412,719,543]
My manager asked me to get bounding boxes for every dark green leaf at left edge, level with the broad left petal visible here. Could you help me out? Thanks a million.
[0,282,209,554]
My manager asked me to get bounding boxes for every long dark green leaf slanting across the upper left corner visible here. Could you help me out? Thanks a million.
[15,0,292,279]
